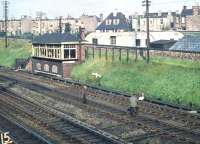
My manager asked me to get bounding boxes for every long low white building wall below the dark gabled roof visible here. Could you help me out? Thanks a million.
[85,31,184,47]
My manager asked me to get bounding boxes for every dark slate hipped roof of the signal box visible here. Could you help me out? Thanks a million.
[32,33,79,44]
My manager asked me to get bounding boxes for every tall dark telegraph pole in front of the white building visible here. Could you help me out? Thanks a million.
[142,0,151,63]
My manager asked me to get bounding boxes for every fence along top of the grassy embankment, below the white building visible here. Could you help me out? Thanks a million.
[84,44,200,62]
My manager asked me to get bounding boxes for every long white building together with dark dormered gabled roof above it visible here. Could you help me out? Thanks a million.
[85,12,183,47]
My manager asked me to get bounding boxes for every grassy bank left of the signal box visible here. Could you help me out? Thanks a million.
[0,39,31,67]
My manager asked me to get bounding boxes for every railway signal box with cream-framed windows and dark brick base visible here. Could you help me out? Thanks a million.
[32,33,85,78]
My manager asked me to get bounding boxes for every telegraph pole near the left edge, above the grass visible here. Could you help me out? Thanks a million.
[3,0,8,48]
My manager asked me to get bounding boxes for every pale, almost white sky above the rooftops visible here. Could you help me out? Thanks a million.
[0,0,200,18]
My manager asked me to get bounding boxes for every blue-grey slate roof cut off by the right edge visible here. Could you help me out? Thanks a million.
[170,35,200,52]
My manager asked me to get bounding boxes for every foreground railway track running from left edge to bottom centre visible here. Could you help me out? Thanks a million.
[1,87,122,144]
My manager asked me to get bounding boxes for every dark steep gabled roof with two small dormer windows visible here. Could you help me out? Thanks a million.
[96,12,131,31]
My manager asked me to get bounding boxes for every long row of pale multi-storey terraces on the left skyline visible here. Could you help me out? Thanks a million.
[0,15,100,36]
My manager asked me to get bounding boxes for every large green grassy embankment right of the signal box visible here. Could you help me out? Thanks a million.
[72,57,200,108]
